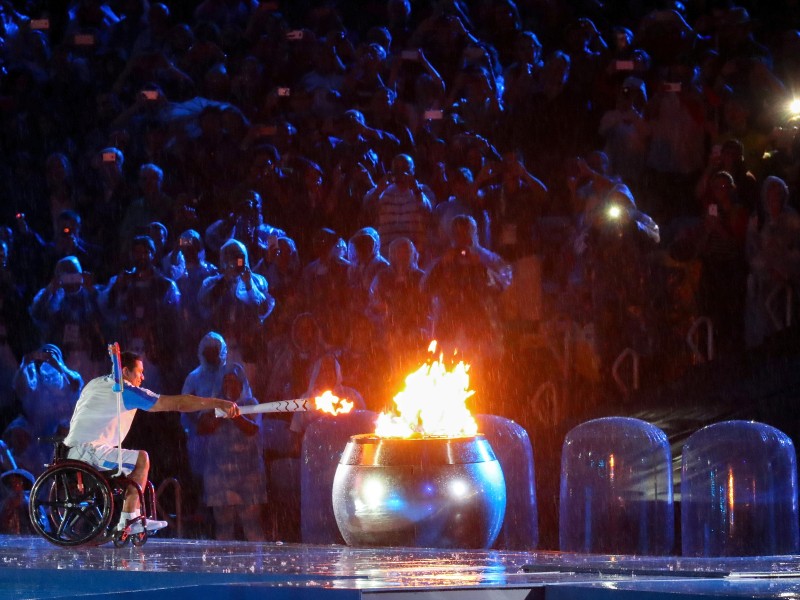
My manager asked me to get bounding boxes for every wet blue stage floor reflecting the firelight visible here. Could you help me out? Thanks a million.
[0,536,800,600]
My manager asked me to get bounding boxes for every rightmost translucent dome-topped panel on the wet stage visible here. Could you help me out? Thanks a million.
[681,421,799,556]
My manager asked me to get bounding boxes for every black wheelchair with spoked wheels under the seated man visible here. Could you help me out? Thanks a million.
[28,440,156,548]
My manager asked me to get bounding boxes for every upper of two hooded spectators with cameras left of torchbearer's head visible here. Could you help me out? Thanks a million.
[30,256,103,379]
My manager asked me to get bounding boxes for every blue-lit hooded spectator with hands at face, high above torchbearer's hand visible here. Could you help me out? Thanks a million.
[197,240,275,376]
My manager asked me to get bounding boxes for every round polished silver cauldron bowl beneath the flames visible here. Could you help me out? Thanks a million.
[333,434,506,548]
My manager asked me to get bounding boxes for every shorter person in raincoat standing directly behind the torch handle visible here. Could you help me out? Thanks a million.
[198,363,267,541]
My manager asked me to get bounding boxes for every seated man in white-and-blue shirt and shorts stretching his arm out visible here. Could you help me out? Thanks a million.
[64,352,239,534]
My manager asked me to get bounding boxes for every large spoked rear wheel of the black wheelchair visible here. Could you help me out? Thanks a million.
[29,461,114,546]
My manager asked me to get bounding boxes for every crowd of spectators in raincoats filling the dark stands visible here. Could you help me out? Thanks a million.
[0,0,800,539]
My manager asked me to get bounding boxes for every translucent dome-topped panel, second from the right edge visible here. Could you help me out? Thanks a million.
[559,417,675,555]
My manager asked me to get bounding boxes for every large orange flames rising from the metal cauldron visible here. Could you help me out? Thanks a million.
[375,341,478,438]
